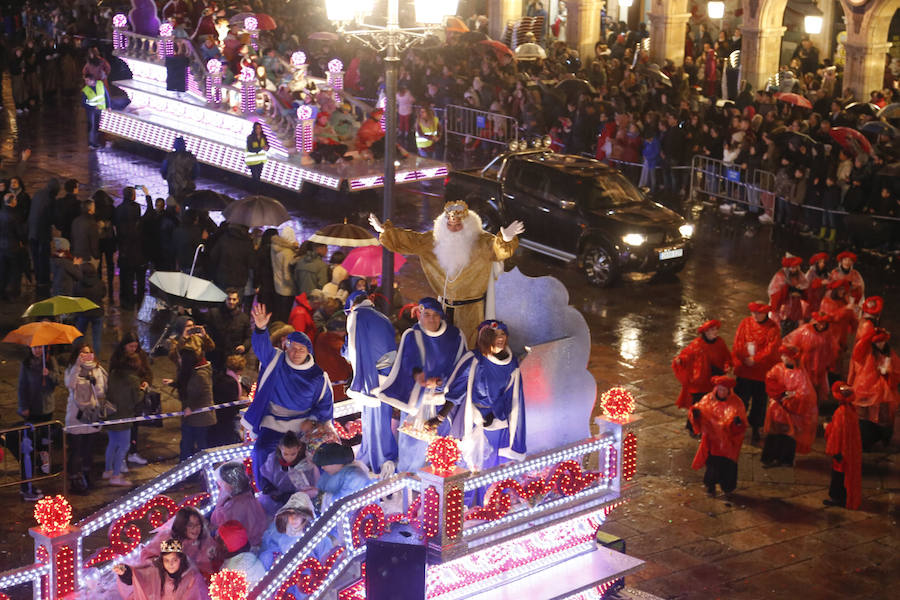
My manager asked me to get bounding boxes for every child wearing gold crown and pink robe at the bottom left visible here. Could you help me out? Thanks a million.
[113,539,209,600]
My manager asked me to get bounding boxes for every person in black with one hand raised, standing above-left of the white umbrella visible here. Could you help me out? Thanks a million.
[113,186,153,310]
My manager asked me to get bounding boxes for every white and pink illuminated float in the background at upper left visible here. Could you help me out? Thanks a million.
[100,23,448,192]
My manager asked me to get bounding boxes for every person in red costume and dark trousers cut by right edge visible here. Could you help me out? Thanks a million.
[851,327,900,452]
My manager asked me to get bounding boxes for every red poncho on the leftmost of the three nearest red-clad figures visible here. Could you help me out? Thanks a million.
[690,390,747,469]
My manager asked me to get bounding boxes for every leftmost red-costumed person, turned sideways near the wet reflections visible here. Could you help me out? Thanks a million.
[672,319,731,431]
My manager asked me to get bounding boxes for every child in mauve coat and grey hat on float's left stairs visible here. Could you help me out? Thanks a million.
[209,462,269,546]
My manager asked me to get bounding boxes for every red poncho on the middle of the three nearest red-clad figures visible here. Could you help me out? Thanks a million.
[764,363,819,454]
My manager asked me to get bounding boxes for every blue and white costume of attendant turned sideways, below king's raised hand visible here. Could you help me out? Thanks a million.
[342,291,398,473]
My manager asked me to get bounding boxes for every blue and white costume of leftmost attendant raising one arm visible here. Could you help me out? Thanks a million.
[242,328,334,481]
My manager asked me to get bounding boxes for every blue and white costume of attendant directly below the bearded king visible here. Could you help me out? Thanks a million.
[378,298,466,472]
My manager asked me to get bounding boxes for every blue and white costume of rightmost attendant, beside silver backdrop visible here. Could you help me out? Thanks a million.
[445,323,526,470]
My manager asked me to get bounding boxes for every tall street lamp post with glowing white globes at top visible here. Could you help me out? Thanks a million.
[325,0,458,307]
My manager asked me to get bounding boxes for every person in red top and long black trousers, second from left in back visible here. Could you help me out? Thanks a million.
[731,302,781,443]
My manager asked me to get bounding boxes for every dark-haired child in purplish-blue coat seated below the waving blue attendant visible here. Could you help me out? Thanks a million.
[257,431,318,518]
